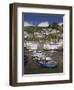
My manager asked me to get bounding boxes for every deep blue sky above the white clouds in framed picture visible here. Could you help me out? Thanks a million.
[23,13,63,25]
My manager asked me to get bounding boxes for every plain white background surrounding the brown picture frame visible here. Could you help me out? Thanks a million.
[0,0,74,90]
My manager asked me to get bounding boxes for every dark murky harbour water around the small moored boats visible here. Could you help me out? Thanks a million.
[24,50,63,74]
